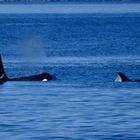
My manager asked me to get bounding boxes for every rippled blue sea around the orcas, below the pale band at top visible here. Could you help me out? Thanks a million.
[0,3,140,140]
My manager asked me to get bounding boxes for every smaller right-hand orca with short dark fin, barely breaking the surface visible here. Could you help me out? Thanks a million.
[115,72,140,82]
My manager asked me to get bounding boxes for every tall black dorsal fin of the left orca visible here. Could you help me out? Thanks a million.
[0,55,8,81]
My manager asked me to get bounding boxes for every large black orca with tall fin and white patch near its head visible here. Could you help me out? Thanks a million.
[0,55,55,84]
